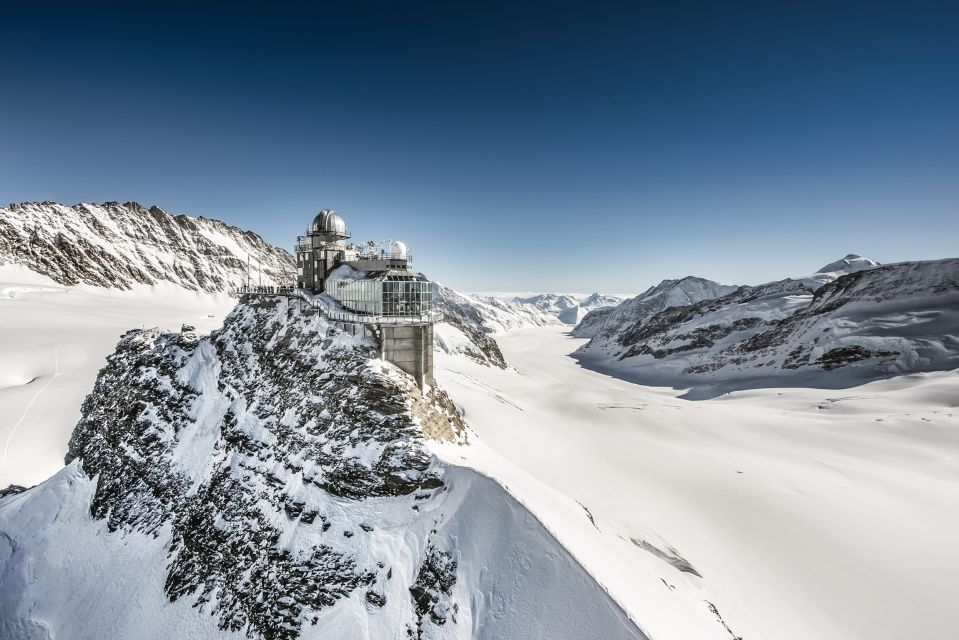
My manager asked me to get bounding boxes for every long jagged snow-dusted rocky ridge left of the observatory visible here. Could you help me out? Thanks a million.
[0,202,295,292]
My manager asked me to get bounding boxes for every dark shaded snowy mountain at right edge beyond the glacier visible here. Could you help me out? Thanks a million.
[576,256,959,392]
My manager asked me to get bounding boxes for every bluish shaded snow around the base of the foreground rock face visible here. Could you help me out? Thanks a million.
[0,464,645,640]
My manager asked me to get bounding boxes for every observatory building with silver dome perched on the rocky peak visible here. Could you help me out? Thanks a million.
[296,209,437,388]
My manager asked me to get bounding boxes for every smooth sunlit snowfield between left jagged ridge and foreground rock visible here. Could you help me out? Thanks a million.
[0,265,236,488]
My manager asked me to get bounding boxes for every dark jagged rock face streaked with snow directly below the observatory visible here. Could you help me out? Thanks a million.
[67,299,463,639]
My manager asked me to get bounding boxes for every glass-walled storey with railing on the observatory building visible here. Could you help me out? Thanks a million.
[326,275,433,316]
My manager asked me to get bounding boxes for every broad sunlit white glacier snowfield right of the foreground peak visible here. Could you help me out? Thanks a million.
[437,327,959,640]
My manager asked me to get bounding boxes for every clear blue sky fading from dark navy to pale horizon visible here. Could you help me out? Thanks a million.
[0,2,959,292]
